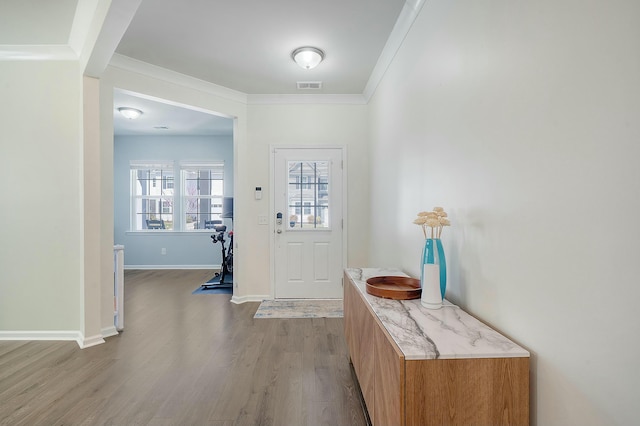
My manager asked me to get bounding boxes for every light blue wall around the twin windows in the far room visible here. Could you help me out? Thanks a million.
[113,135,234,269]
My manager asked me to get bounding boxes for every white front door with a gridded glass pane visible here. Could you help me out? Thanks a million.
[273,148,344,299]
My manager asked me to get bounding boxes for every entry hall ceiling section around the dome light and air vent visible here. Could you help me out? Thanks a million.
[116,0,404,94]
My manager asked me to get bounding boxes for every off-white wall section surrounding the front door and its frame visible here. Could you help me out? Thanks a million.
[244,104,369,295]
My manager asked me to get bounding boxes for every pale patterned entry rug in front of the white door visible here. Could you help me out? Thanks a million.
[253,299,343,318]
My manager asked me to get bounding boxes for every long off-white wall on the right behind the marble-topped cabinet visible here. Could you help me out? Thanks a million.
[369,0,640,426]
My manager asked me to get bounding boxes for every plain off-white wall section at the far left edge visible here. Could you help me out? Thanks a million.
[0,61,84,337]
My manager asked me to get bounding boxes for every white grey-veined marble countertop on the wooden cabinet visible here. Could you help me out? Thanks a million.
[345,268,529,360]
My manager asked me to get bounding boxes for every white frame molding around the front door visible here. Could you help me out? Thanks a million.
[269,144,349,299]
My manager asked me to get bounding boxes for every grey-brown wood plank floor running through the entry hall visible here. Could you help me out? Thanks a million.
[0,270,366,426]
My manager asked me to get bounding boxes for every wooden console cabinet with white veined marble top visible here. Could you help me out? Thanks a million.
[344,268,529,426]
